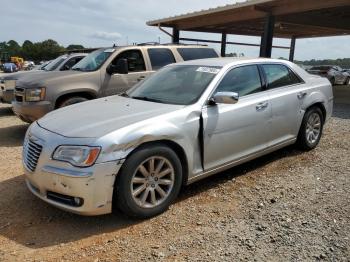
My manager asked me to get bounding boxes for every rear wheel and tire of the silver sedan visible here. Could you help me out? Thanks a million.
[297,107,324,151]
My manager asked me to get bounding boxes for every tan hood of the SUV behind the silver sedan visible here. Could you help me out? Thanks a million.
[17,70,86,88]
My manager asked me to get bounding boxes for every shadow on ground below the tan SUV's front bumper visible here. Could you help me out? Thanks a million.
[0,124,29,147]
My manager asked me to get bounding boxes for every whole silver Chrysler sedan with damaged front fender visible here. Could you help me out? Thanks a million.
[23,58,333,218]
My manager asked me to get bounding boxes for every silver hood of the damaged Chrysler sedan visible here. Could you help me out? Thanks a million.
[38,96,184,138]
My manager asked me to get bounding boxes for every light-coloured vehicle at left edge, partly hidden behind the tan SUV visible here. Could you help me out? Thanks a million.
[0,53,87,104]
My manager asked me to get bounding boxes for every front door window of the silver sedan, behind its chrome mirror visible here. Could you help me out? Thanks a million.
[215,65,263,96]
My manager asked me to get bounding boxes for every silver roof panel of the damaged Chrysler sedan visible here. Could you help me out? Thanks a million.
[170,57,290,67]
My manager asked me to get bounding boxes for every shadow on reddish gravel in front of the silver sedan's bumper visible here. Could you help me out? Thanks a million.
[0,176,141,249]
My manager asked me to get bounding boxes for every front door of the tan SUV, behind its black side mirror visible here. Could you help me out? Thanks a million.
[102,49,153,96]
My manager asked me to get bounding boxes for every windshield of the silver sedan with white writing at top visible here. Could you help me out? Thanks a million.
[127,65,221,105]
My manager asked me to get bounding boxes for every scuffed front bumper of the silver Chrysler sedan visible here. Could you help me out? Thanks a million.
[25,162,122,216]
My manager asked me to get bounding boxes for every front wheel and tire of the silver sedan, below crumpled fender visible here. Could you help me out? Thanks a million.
[113,144,182,219]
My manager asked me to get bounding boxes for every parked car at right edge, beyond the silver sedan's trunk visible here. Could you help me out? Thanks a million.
[307,66,350,85]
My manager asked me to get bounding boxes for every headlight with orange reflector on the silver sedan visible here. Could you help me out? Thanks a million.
[52,146,101,167]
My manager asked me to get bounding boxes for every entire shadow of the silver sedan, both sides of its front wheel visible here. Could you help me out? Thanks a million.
[0,147,302,249]
